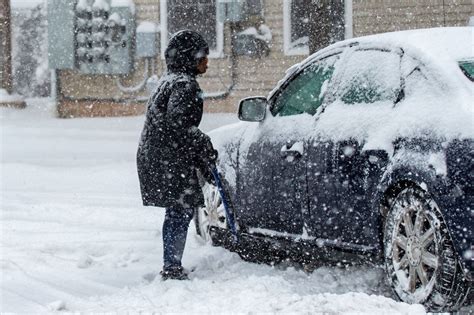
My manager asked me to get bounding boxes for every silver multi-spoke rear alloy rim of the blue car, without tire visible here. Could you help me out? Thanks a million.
[388,189,440,303]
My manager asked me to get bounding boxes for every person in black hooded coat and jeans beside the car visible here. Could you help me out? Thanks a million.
[137,30,217,280]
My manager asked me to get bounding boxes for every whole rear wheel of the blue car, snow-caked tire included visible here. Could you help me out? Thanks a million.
[384,187,469,312]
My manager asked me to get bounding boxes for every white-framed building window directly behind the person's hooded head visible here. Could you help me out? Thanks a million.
[160,0,224,58]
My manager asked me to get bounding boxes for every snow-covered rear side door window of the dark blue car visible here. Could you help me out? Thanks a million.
[336,50,401,104]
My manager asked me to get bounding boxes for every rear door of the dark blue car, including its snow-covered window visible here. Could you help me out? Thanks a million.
[307,48,401,249]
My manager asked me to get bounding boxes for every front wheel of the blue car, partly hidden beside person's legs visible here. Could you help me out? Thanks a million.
[194,183,227,243]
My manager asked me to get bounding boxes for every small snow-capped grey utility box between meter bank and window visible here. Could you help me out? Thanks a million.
[135,21,160,58]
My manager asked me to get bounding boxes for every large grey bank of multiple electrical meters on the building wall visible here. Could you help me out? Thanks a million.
[48,0,135,74]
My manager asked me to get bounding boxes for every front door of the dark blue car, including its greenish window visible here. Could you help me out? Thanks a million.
[238,56,337,235]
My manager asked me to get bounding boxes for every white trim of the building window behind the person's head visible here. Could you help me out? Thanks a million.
[160,0,224,58]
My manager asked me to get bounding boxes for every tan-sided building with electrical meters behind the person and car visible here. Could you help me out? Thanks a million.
[48,0,474,117]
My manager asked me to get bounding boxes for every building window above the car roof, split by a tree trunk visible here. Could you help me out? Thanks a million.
[283,0,352,55]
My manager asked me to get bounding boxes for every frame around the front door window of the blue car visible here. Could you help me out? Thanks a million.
[268,49,344,117]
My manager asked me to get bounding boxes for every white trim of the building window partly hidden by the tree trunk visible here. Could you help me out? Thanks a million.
[283,0,353,56]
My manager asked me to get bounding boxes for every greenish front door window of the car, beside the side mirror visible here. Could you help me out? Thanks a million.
[271,56,337,116]
